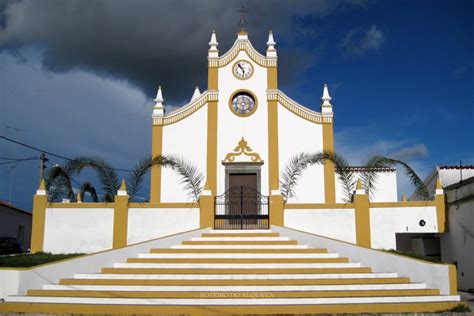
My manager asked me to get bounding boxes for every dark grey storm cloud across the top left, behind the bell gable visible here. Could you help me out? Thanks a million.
[0,0,365,102]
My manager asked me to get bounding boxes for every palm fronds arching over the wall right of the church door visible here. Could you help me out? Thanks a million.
[280,152,429,202]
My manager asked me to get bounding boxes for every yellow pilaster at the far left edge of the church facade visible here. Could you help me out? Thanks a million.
[150,125,163,203]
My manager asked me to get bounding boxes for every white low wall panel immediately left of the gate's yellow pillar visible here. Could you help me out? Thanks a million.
[127,208,199,244]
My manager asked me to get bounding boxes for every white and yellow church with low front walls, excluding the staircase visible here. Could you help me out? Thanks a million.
[25,31,445,253]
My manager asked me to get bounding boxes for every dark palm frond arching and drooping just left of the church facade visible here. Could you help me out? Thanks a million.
[65,157,120,202]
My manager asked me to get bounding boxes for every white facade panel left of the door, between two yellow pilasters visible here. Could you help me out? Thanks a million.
[161,105,207,203]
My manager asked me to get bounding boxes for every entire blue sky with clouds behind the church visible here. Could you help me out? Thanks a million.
[0,0,474,210]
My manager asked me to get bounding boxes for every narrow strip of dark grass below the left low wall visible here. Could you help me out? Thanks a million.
[0,252,83,268]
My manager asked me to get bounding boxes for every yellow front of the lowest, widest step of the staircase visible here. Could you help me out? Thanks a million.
[0,302,459,315]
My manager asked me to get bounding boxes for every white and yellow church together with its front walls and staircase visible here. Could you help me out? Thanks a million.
[0,28,460,314]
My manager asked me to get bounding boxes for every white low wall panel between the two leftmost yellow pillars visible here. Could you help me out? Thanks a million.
[43,208,114,253]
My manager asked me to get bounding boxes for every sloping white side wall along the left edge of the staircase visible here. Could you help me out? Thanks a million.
[0,228,209,299]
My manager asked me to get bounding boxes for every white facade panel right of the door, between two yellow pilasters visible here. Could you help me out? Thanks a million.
[278,104,324,203]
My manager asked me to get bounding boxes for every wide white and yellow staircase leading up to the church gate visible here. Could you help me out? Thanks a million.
[2,230,459,315]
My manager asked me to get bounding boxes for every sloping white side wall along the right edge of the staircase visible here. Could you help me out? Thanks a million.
[272,225,456,295]
